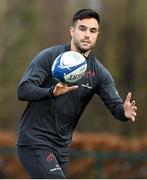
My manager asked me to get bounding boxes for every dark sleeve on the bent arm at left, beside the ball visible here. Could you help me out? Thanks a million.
[17,52,54,101]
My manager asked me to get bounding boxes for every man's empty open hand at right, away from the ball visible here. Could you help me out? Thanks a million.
[124,92,137,122]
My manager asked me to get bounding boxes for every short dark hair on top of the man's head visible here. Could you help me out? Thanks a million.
[72,9,100,25]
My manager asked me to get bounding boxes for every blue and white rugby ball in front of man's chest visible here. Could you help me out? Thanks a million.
[51,51,87,84]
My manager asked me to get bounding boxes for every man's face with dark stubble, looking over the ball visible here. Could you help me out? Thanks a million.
[70,18,99,54]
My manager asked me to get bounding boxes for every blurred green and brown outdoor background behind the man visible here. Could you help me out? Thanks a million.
[0,0,147,178]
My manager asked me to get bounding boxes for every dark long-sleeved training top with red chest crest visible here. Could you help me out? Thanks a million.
[17,44,127,162]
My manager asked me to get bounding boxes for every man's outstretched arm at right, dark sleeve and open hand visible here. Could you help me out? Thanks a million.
[97,70,137,122]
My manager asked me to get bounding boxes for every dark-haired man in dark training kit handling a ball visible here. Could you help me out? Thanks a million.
[17,9,137,179]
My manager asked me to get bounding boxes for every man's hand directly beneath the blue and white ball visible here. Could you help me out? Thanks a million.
[53,82,78,96]
